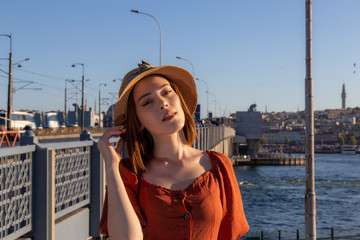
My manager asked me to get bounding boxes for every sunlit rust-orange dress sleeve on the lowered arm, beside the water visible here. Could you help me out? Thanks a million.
[212,152,250,240]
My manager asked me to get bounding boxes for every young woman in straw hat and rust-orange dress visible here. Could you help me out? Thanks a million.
[98,62,249,240]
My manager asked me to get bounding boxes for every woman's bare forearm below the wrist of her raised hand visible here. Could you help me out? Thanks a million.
[106,165,143,240]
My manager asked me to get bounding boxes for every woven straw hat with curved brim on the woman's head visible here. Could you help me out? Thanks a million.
[114,61,197,126]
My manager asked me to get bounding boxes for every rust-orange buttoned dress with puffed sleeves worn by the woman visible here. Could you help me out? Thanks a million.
[99,151,250,240]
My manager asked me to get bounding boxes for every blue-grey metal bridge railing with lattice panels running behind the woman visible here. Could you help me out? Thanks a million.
[0,126,235,240]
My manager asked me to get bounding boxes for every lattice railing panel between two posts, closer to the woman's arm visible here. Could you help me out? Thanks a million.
[55,146,90,216]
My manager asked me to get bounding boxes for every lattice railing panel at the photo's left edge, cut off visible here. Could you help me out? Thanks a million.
[0,152,32,239]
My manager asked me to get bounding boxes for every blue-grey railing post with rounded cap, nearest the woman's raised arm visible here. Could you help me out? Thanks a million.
[80,130,105,237]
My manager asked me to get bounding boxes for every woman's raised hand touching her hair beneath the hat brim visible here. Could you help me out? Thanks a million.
[97,125,126,166]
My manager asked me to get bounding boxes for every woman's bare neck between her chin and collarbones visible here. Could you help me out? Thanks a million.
[153,131,189,162]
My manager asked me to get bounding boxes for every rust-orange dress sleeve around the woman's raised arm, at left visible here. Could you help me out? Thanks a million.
[99,159,146,235]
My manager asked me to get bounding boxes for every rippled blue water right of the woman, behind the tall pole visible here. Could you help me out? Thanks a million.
[235,154,360,239]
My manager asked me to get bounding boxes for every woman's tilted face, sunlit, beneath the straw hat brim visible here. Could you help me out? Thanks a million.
[134,75,185,137]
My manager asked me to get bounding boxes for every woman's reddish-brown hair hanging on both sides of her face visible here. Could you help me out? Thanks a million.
[124,75,196,175]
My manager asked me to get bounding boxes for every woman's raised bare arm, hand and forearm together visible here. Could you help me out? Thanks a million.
[98,126,143,240]
